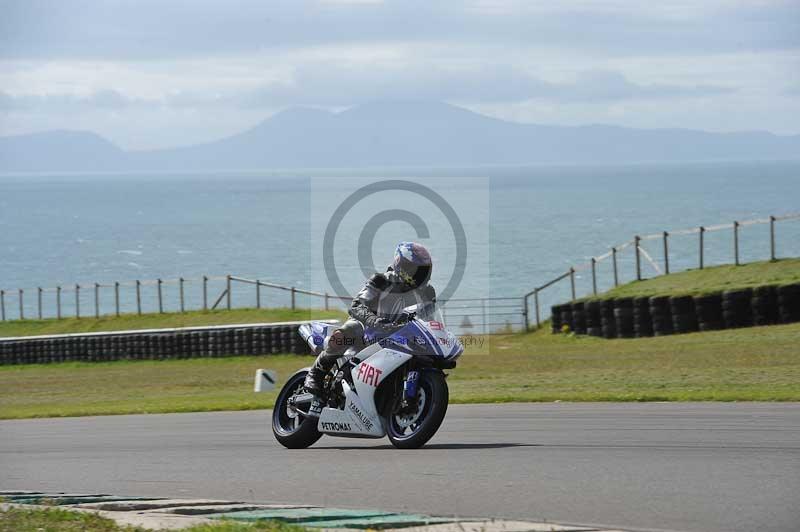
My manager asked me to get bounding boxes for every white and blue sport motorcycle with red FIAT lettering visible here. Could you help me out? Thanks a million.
[272,305,464,449]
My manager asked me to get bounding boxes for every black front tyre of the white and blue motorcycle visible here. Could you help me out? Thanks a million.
[385,371,450,449]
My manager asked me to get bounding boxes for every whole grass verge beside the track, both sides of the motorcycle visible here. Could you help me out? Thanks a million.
[0,324,800,419]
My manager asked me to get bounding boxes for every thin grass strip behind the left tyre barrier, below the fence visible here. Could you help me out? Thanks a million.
[0,308,344,337]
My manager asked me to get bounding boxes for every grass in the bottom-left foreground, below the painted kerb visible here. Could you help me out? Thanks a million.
[0,507,308,532]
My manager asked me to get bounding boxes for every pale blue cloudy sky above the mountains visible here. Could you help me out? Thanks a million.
[0,0,800,149]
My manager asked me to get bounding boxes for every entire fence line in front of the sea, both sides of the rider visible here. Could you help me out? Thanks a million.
[0,213,800,334]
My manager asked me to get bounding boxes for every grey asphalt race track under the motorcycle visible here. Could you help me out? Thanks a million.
[0,403,800,532]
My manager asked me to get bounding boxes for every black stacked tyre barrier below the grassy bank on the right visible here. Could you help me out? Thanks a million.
[552,283,800,338]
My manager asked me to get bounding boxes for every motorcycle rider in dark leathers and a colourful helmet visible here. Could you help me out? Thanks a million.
[304,242,436,397]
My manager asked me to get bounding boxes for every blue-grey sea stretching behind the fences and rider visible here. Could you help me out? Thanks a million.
[0,162,800,319]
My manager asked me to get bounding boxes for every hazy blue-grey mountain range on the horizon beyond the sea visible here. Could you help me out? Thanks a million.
[0,102,800,171]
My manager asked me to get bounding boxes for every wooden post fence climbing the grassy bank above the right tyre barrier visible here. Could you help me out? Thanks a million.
[523,213,800,330]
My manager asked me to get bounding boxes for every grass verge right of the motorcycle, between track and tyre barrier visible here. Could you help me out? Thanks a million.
[460,324,800,402]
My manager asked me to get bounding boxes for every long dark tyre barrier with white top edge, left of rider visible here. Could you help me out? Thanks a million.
[0,323,332,365]
